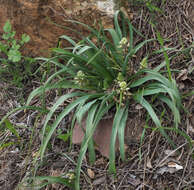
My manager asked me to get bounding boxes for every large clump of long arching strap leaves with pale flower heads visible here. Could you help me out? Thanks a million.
[27,11,190,190]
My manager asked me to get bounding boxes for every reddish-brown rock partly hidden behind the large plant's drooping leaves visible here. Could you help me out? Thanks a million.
[72,114,144,158]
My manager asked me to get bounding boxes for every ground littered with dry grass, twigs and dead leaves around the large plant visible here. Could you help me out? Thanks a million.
[0,0,194,190]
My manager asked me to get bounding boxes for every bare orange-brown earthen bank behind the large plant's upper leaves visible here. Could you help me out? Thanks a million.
[0,0,112,56]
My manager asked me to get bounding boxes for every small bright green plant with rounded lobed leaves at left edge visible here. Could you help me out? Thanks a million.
[0,21,34,87]
